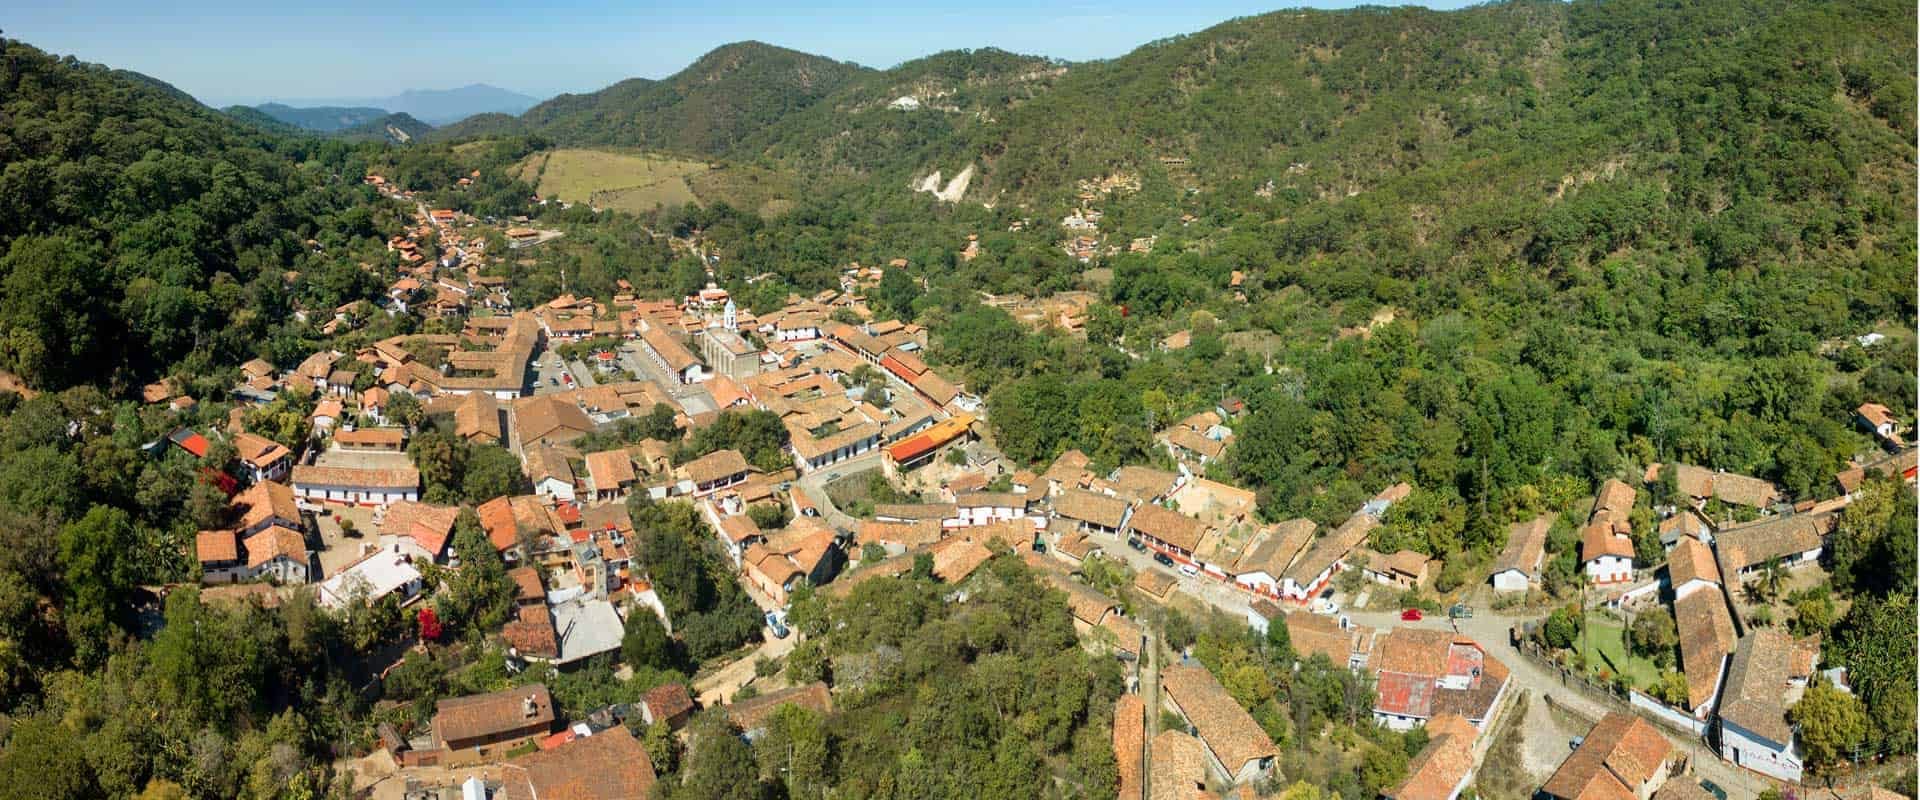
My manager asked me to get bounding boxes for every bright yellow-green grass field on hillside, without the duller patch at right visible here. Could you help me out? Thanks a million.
[520,148,707,211]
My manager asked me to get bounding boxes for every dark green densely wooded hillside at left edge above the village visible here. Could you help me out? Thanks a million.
[0,38,390,389]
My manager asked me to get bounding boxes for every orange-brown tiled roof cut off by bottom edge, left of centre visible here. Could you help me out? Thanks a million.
[501,725,657,800]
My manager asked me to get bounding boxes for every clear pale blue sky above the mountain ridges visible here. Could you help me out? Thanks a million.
[11,0,1465,106]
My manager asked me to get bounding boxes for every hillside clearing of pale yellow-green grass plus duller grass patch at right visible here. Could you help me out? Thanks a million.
[518,148,795,215]
